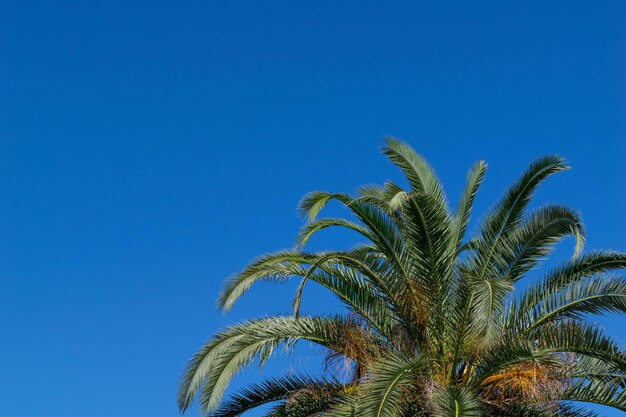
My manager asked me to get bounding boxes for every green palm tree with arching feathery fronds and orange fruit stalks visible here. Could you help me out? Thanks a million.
[178,139,626,417]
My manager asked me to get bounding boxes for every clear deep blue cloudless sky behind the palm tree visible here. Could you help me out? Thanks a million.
[0,0,626,417]
